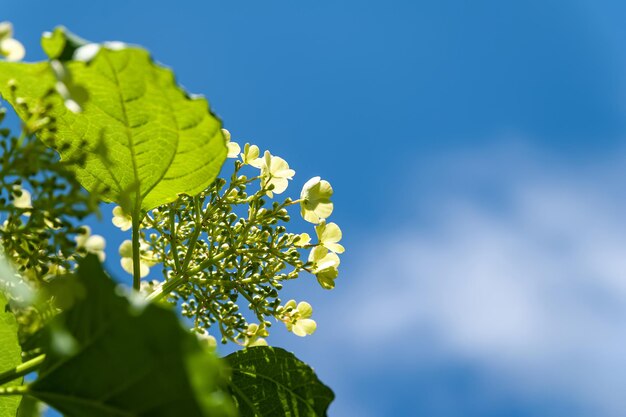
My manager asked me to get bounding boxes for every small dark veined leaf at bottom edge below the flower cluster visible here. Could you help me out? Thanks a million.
[226,346,335,417]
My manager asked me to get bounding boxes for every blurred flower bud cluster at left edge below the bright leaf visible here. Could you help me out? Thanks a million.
[0,91,100,341]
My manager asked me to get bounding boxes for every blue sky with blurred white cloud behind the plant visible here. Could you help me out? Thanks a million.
[6,0,626,417]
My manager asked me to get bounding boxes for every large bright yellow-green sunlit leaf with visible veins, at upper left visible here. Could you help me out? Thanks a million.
[0,29,226,213]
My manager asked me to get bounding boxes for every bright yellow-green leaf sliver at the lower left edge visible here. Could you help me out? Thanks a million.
[0,292,22,417]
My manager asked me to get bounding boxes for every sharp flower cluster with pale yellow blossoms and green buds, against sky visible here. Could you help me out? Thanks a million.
[112,130,344,346]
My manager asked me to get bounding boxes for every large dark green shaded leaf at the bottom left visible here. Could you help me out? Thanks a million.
[28,255,233,417]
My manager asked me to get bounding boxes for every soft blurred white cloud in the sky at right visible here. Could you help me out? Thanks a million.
[319,141,626,416]
